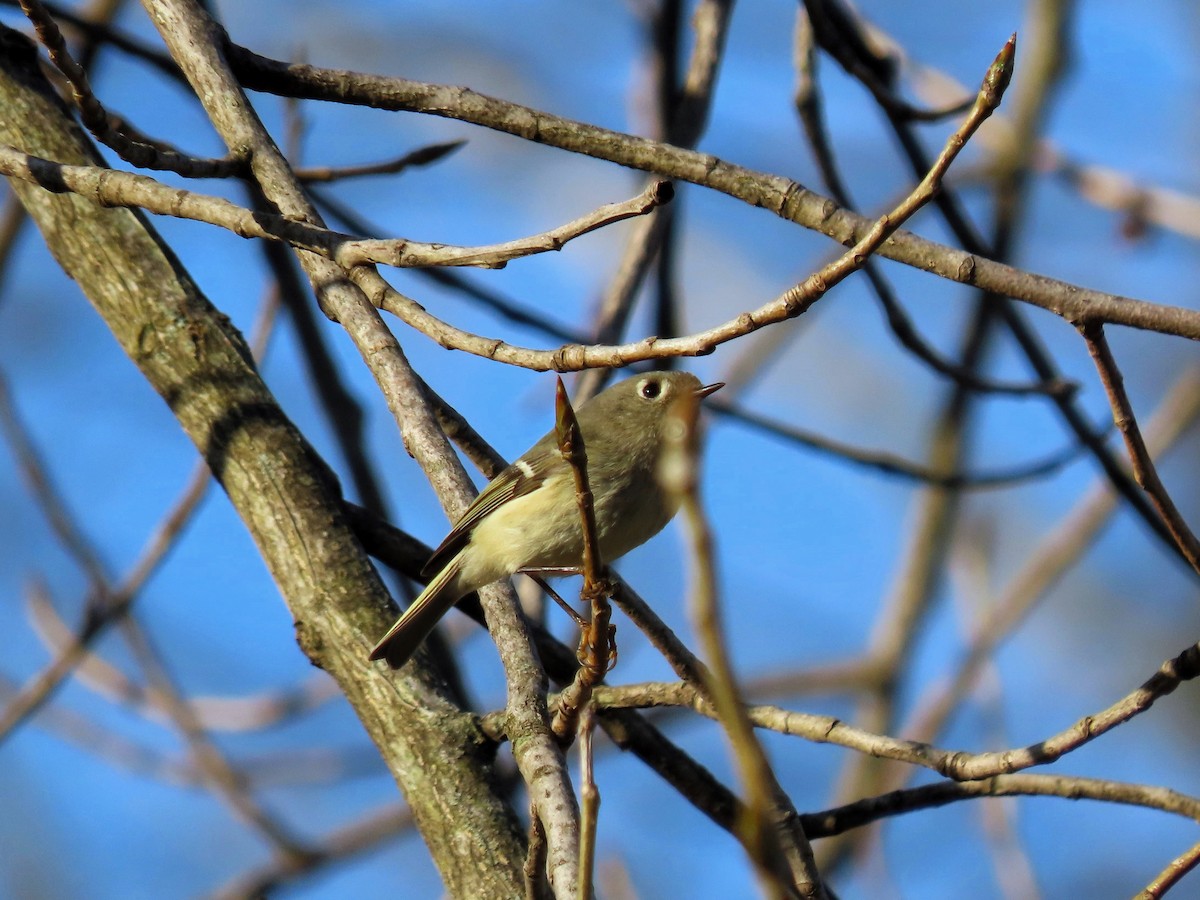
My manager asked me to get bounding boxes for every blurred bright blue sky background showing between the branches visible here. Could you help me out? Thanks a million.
[0,0,1200,900]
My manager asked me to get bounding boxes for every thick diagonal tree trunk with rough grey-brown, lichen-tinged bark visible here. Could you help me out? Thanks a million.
[0,26,524,898]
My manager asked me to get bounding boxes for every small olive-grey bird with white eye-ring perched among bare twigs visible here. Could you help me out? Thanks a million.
[370,372,724,668]
